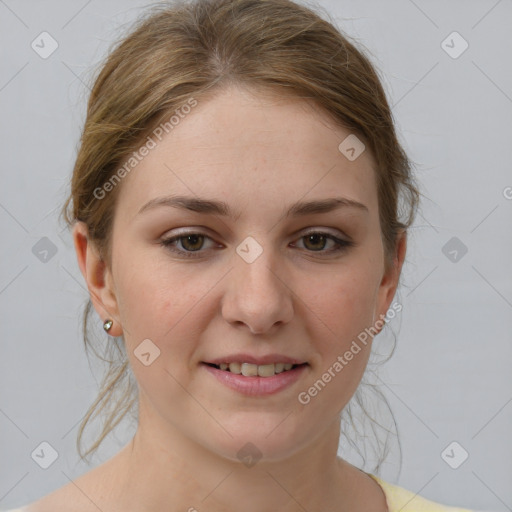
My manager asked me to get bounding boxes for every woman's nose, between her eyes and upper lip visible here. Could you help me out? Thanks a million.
[222,250,293,334]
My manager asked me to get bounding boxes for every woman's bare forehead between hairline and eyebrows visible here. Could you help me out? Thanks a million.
[117,88,377,222]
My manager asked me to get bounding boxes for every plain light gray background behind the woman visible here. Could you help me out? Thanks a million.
[0,0,512,511]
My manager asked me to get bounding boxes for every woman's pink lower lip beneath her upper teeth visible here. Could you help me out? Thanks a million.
[202,363,308,396]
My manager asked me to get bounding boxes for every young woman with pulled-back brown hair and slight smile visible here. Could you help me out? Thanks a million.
[6,0,482,512]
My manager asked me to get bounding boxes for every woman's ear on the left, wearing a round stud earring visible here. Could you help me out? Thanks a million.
[73,221,123,336]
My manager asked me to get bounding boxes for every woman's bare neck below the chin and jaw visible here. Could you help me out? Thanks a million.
[116,400,371,512]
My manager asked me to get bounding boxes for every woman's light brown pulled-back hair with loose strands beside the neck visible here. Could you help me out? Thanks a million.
[61,0,420,472]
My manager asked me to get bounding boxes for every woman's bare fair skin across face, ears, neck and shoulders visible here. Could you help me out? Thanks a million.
[34,88,406,512]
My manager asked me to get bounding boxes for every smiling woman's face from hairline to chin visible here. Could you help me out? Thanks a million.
[74,85,405,460]
